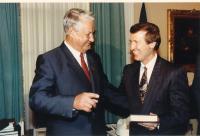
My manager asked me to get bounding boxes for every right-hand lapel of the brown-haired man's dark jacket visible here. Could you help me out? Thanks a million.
[142,56,163,114]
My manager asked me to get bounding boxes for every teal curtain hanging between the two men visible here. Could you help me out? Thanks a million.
[90,3,126,123]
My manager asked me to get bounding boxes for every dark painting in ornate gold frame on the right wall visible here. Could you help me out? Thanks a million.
[167,9,200,72]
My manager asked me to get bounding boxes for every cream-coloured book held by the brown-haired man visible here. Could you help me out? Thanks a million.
[128,114,158,122]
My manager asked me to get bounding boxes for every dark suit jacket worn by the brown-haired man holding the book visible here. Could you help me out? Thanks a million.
[119,56,189,135]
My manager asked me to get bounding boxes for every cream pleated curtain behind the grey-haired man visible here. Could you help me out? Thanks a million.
[20,3,89,129]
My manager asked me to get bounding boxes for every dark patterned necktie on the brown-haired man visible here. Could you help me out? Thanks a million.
[139,67,148,104]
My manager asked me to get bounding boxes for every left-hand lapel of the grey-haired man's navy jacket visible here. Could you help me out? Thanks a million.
[60,42,90,84]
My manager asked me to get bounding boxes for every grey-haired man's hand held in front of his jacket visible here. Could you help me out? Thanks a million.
[73,92,99,112]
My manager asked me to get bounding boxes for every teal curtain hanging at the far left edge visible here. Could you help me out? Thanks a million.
[0,3,23,122]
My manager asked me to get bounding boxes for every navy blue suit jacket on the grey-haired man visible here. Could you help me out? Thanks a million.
[29,43,114,136]
